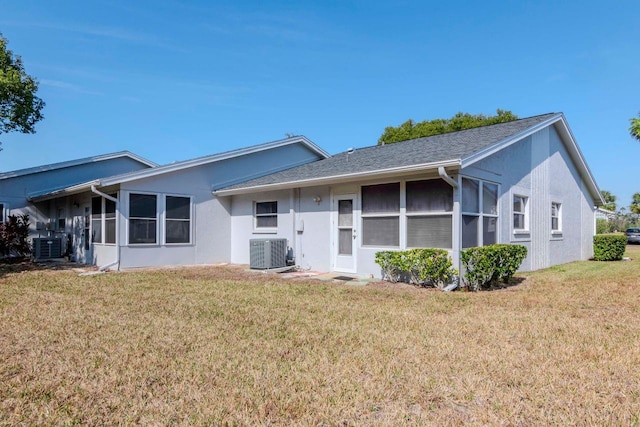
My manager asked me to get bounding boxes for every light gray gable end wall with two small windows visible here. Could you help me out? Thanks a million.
[468,126,594,271]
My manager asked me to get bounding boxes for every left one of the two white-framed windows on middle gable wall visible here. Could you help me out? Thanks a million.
[129,193,158,245]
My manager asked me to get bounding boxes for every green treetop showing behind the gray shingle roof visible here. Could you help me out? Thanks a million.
[378,109,518,145]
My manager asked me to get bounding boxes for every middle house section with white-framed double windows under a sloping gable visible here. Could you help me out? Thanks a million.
[23,136,329,268]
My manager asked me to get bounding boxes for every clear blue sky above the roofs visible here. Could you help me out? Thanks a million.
[0,0,640,206]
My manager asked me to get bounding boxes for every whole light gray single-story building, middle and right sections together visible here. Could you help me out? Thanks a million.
[0,113,603,277]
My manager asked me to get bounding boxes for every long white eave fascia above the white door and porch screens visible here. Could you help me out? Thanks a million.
[213,159,460,196]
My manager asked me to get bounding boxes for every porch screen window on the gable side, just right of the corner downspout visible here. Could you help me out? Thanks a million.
[462,178,498,248]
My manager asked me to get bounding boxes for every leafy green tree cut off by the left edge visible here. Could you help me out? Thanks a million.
[0,33,44,148]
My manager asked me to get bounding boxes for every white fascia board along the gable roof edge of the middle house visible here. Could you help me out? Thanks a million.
[101,136,331,186]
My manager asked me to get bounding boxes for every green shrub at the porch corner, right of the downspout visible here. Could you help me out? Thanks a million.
[460,244,527,291]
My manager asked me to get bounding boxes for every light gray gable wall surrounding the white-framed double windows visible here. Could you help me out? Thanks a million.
[112,144,318,268]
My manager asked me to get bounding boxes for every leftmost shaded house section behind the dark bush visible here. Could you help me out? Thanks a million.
[0,151,157,262]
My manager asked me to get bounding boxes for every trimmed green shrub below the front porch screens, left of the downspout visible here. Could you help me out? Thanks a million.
[375,248,457,288]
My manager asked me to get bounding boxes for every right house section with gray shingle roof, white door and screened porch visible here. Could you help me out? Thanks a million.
[215,113,603,277]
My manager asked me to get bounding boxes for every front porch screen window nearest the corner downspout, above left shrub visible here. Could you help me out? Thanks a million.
[406,179,453,249]
